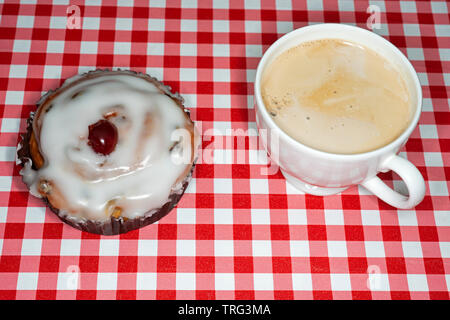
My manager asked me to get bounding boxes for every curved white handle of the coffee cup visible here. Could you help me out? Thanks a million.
[361,155,425,209]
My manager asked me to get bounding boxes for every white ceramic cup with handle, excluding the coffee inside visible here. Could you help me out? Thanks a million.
[255,23,425,209]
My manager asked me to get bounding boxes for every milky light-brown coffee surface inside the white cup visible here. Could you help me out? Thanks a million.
[261,39,412,154]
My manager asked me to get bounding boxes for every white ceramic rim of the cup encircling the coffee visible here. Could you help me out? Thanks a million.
[254,23,422,160]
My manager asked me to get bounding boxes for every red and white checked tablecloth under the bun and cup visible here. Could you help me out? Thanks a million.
[0,0,450,299]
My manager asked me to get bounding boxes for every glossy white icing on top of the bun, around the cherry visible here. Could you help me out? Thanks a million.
[21,71,198,221]
